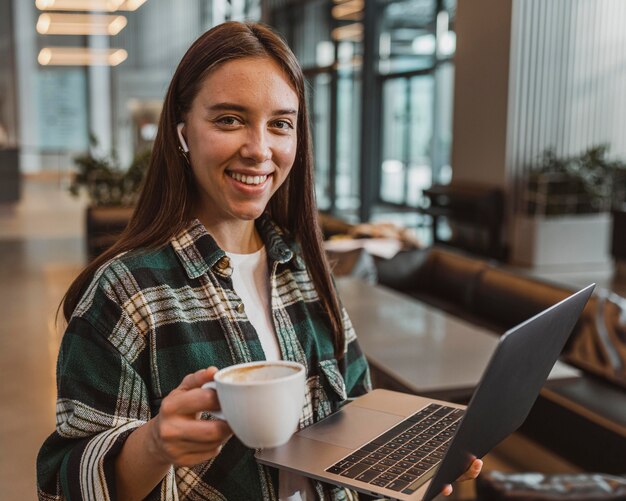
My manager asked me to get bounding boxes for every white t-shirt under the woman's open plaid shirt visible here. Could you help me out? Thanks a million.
[226,247,315,501]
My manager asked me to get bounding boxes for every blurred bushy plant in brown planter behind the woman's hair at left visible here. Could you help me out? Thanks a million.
[69,138,150,260]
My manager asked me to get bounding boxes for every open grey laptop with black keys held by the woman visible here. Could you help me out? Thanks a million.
[256,284,595,500]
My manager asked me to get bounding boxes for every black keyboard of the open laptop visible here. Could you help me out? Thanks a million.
[326,404,463,494]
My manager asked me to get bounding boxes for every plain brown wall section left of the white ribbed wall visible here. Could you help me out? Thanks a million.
[452,0,512,186]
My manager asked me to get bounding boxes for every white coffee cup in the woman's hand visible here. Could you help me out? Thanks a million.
[202,360,306,449]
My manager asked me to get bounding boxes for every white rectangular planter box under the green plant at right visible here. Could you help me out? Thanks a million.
[512,212,611,266]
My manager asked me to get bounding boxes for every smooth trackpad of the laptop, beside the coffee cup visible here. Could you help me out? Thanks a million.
[298,405,404,449]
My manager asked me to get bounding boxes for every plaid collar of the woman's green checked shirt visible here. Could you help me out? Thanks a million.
[170,214,299,279]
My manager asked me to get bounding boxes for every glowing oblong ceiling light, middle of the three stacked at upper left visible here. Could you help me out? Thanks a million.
[37,13,127,35]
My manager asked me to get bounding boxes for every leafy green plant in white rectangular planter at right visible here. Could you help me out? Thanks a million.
[513,145,626,266]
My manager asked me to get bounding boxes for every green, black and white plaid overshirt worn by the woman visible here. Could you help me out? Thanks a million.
[37,216,370,500]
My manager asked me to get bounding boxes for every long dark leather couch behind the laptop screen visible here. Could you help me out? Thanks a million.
[376,247,626,474]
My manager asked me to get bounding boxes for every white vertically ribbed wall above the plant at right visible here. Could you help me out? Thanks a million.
[507,0,626,177]
